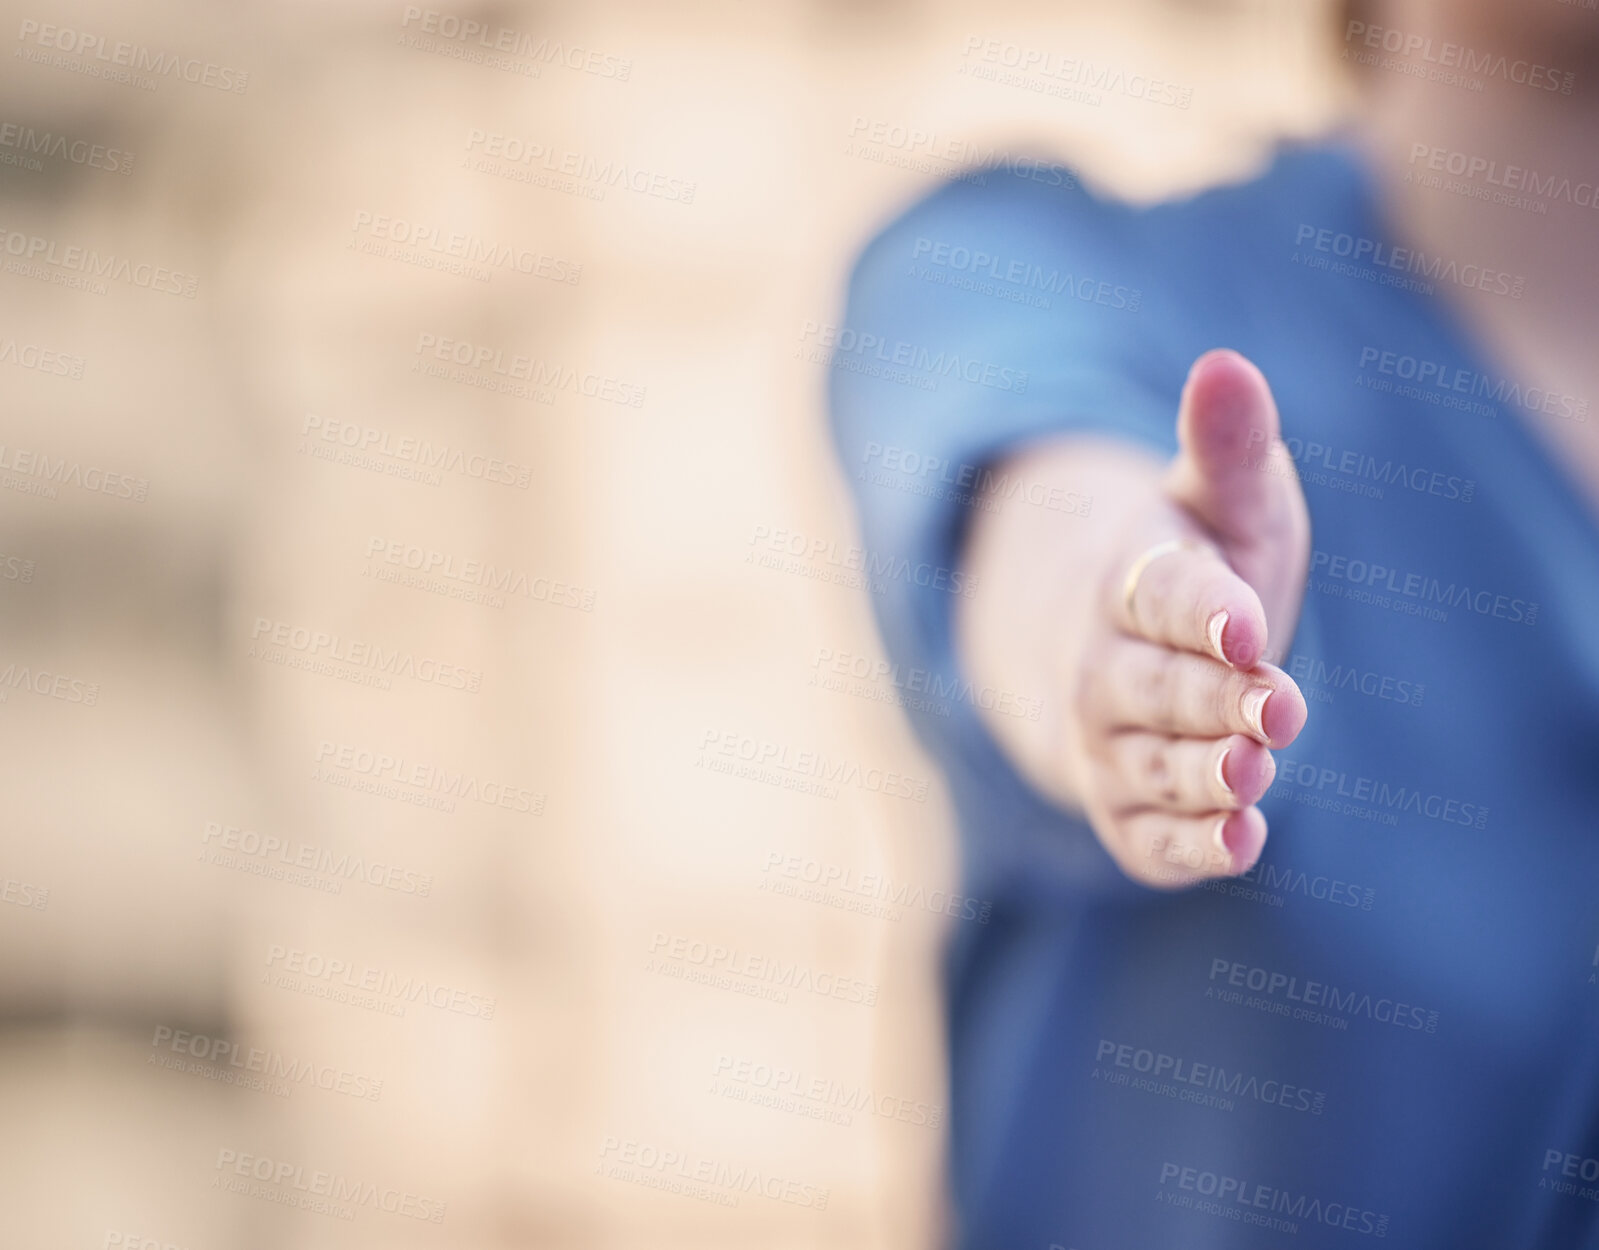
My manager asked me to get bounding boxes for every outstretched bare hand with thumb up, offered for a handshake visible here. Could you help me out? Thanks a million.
[958,350,1310,889]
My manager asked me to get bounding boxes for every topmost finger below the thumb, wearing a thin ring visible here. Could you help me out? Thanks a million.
[1116,539,1266,668]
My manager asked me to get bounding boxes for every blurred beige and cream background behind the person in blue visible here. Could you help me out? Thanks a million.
[0,0,1338,1250]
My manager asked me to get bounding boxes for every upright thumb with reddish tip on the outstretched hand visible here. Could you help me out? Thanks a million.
[1166,348,1308,551]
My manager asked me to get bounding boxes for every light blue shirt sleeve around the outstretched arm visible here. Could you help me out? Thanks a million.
[815,173,1182,898]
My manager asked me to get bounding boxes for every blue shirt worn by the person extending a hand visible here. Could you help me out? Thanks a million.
[830,147,1599,1250]
